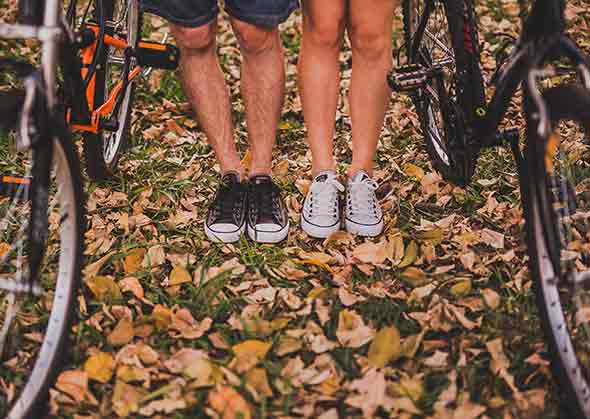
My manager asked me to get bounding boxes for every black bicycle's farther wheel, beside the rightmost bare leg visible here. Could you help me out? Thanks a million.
[403,0,485,185]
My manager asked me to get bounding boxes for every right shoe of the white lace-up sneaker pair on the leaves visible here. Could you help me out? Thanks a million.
[346,170,383,237]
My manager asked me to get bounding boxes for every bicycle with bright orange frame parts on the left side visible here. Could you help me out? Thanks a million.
[0,0,178,419]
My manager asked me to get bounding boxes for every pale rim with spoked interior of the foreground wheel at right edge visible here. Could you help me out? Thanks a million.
[535,121,590,417]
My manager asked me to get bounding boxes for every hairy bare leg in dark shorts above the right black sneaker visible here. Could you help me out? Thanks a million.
[231,18,285,175]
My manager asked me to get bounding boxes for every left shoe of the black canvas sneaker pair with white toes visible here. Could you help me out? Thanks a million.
[205,172,247,243]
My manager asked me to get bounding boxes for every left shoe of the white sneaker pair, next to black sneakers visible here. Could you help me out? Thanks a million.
[301,171,344,239]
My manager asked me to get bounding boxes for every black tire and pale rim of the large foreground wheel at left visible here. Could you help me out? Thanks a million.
[5,120,85,419]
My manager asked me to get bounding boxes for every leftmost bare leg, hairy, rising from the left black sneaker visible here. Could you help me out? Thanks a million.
[171,20,243,175]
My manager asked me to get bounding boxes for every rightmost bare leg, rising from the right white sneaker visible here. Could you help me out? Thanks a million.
[347,0,397,177]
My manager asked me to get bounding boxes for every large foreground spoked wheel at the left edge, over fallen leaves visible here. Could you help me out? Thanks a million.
[0,116,84,419]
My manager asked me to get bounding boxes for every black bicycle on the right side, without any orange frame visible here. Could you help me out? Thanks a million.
[388,0,590,418]
